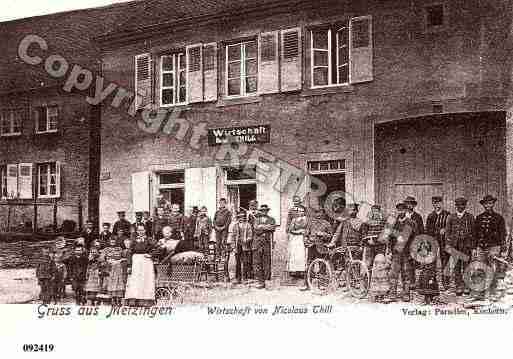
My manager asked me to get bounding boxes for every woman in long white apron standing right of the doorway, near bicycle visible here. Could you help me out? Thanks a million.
[287,207,308,276]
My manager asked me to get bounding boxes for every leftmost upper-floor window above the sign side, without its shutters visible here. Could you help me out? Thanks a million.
[160,52,187,106]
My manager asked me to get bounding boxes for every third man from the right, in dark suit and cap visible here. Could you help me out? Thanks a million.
[426,196,451,289]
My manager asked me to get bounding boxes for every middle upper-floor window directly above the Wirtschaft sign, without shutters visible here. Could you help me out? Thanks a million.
[226,40,258,97]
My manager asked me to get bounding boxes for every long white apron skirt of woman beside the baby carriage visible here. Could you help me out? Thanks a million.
[125,254,155,300]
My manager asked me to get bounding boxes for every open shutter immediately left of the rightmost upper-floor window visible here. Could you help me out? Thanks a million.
[281,28,302,92]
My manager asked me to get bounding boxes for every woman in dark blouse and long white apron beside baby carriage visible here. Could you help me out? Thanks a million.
[125,224,155,306]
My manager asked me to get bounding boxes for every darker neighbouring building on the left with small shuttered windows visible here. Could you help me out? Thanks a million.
[0,5,134,231]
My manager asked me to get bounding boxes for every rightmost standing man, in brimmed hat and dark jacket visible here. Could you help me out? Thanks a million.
[473,195,506,299]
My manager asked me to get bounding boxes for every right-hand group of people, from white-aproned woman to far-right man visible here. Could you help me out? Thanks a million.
[287,195,511,303]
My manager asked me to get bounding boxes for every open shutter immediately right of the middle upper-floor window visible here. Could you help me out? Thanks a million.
[258,31,280,94]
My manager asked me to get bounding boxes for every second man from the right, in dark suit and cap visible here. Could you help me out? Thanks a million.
[446,197,474,296]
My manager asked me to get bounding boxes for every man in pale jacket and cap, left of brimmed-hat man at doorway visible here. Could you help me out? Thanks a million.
[227,211,253,284]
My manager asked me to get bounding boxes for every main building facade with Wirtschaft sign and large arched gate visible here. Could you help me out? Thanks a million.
[99,0,512,268]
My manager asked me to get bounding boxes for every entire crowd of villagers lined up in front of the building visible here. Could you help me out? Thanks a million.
[36,195,511,305]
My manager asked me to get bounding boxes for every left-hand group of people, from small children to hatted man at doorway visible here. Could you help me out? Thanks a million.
[36,199,276,305]
